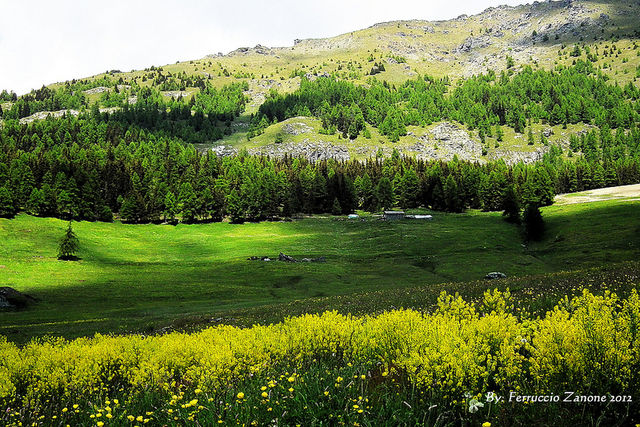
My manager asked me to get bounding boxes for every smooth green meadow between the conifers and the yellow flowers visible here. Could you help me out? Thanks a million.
[0,200,640,342]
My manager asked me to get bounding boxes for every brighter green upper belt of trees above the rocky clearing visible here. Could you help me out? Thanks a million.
[253,60,640,147]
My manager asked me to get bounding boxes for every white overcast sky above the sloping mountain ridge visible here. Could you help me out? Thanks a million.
[0,0,527,94]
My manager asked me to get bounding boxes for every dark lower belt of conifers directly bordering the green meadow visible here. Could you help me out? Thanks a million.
[0,109,640,223]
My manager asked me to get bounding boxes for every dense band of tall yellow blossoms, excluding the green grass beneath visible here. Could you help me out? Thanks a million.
[0,291,640,409]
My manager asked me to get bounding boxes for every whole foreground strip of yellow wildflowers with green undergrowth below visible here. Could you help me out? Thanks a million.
[0,290,640,426]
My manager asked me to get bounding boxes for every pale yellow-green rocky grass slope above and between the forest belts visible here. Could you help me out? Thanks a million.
[3,0,640,161]
